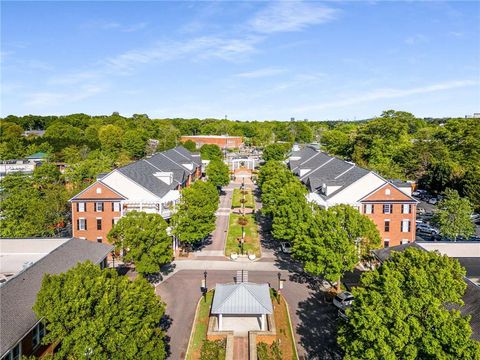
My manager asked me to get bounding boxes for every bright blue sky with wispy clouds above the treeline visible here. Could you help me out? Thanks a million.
[1,1,480,120]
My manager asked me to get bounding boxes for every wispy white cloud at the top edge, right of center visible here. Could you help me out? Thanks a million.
[249,1,338,34]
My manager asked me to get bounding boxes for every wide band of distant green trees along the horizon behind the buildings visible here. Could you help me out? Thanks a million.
[0,110,480,208]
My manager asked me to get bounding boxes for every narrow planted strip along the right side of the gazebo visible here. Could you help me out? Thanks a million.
[272,296,297,360]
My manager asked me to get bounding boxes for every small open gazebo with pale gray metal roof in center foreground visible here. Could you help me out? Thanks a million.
[211,282,273,332]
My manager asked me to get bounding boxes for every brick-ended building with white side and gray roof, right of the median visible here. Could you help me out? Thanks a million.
[288,146,417,247]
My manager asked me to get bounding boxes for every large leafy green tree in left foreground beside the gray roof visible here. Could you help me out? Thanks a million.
[33,262,166,360]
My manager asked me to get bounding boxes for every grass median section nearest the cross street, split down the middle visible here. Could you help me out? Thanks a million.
[225,214,260,257]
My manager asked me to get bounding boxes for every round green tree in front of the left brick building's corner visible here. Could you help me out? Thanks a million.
[107,211,173,275]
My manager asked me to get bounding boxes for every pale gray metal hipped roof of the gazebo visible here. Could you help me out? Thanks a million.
[212,283,273,315]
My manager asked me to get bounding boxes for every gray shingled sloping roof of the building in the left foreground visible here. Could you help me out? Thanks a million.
[0,238,113,357]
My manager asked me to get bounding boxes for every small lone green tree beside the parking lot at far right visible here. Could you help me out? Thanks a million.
[434,189,475,239]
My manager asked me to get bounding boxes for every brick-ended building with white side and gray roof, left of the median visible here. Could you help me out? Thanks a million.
[70,146,202,242]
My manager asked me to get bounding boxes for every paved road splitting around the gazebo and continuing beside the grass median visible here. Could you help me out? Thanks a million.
[156,184,341,360]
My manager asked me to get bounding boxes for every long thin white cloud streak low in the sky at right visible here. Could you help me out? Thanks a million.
[295,80,478,112]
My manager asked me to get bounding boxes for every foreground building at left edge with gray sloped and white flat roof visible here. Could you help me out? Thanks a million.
[0,238,113,360]
